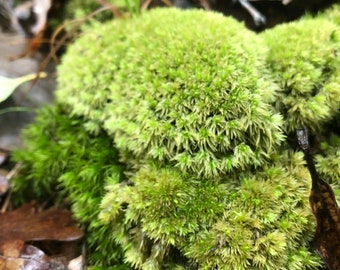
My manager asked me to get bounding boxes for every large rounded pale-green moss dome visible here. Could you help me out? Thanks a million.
[57,9,283,178]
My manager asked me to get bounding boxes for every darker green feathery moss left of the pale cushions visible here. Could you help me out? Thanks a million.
[13,106,126,265]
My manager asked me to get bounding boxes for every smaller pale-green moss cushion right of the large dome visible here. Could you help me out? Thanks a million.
[262,17,340,132]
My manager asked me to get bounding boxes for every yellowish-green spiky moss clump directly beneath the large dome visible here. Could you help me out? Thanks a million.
[100,153,320,269]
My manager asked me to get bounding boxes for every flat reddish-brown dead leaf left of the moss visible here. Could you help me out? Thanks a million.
[0,203,84,245]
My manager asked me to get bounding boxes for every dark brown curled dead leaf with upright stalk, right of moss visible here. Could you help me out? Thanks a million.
[297,129,340,270]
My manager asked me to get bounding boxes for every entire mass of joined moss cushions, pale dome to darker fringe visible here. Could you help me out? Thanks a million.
[14,6,340,270]
